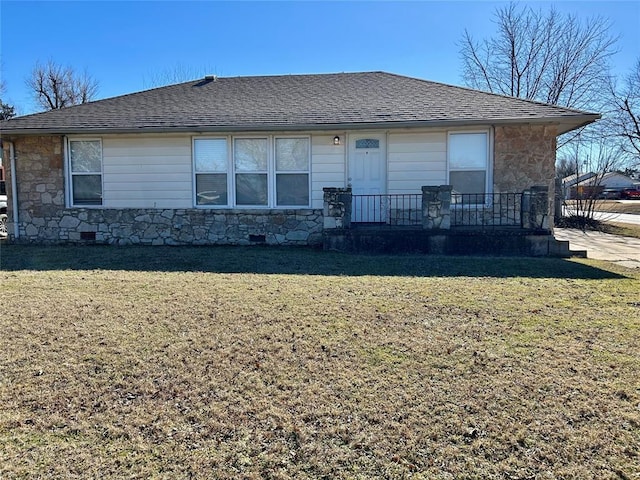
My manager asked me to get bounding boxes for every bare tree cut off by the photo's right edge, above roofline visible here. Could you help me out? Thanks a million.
[609,58,640,167]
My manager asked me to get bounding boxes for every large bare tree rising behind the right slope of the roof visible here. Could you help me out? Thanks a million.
[460,3,616,109]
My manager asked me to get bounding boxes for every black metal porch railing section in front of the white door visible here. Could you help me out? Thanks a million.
[351,193,422,226]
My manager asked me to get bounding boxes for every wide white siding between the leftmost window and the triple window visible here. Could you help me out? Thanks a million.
[102,136,193,208]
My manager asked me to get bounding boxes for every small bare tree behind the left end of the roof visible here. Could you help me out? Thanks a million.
[26,60,98,110]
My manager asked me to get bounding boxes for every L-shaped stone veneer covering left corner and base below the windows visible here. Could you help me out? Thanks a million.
[3,136,323,245]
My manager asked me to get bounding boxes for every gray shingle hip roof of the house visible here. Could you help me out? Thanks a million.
[0,72,599,134]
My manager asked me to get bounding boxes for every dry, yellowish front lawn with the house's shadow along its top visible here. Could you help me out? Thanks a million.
[0,244,640,479]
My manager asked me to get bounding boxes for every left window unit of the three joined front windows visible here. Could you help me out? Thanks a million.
[193,138,229,206]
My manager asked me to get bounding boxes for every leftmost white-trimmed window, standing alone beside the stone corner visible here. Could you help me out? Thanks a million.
[69,140,102,206]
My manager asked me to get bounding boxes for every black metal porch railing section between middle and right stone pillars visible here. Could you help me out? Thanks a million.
[451,193,522,228]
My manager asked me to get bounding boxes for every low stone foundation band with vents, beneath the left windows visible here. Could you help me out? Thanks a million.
[14,208,323,245]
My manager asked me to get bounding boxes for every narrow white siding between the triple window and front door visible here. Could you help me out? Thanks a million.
[311,135,346,208]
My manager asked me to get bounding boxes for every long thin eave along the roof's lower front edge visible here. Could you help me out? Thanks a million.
[0,114,601,136]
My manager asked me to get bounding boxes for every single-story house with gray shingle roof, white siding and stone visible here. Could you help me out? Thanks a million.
[0,72,599,249]
